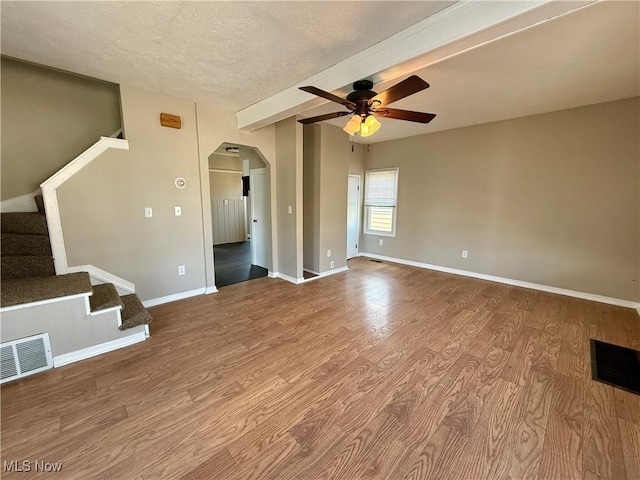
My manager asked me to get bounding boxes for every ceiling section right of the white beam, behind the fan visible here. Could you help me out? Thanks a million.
[312,1,640,143]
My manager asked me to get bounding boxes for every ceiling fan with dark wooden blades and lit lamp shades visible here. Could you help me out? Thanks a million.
[298,75,435,137]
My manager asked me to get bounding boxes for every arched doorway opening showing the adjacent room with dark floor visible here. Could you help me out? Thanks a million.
[209,142,271,288]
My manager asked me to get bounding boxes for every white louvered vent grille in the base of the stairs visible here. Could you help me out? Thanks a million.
[0,333,53,383]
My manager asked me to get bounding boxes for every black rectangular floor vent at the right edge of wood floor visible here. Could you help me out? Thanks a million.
[591,339,640,395]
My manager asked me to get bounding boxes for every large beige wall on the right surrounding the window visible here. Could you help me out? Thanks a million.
[362,98,640,301]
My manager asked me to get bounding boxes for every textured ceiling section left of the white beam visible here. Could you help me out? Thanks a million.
[1,1,454,111]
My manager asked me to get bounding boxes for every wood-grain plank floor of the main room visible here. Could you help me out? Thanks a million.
[2,258,640,480]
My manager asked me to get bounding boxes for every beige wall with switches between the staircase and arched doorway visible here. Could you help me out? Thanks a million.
[58,86,205,300]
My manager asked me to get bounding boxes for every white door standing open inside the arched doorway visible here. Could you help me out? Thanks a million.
[249,168,271,268]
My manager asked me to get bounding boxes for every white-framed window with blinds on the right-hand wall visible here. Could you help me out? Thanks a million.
[364,168,398,237]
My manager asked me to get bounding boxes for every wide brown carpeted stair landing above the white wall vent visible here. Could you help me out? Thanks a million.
[0,272,92,307]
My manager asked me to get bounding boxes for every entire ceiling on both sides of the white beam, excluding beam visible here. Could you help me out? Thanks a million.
[1,1,640,143]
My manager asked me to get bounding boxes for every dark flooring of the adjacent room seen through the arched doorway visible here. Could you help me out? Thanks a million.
[213,241,268,288]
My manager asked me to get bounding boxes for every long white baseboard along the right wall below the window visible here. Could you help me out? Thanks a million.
[360,252,640,313]
